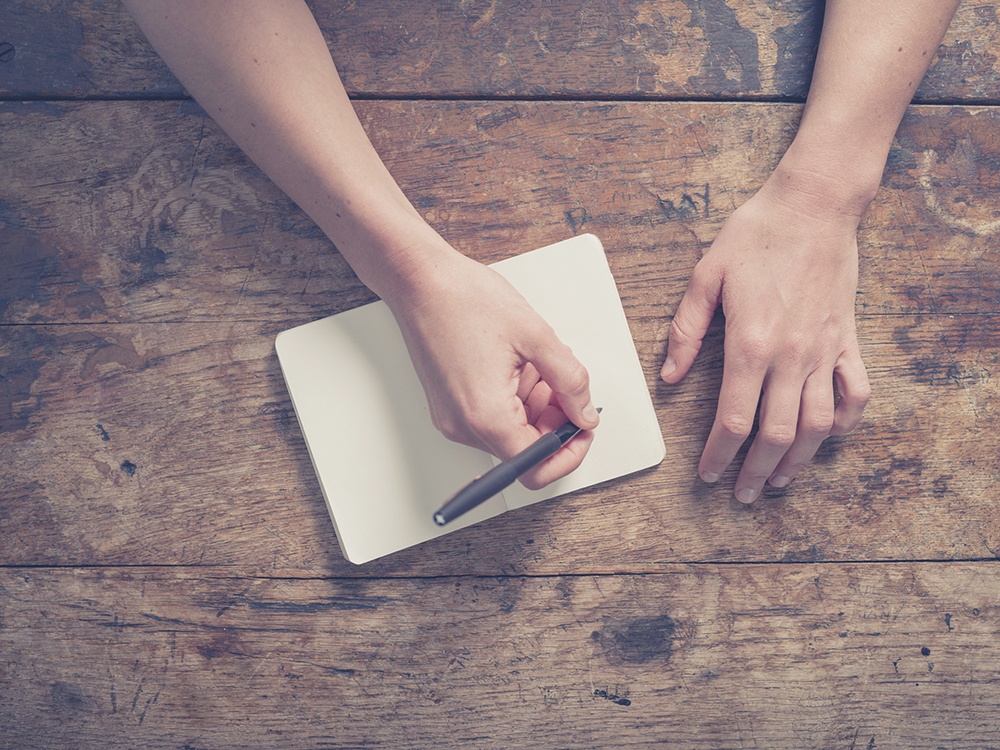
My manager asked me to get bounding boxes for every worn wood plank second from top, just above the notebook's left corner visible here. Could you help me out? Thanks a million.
[0,102,1000,325]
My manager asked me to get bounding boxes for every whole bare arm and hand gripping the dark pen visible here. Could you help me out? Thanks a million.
[126,0,598,486]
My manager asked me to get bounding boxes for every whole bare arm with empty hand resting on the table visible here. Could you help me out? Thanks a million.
[661,0,958,502]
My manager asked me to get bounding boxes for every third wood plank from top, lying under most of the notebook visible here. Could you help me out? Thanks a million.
[0,313,1000,576]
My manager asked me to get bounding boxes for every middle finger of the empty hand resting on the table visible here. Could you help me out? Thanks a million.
[733,379,803,503]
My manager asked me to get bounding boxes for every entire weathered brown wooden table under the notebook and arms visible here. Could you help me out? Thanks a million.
[0,0,1000,750]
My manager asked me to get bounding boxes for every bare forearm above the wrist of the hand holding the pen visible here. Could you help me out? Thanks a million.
[126,0,452,297]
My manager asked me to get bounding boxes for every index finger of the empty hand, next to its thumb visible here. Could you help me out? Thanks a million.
[698,356,764,483]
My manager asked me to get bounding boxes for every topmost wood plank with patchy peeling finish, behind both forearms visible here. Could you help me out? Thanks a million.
[0,0,1000,102]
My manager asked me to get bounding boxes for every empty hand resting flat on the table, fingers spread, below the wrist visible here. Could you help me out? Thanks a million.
[661,168,870,503]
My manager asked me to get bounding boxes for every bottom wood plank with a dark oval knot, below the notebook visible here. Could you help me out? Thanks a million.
[0,563,1000,750]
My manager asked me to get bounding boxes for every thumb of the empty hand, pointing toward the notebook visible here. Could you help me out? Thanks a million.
[660,261,722,383]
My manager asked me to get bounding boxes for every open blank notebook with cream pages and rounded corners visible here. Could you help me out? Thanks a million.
[276,234,664,563]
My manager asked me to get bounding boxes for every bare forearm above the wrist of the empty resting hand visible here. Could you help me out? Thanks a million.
[779,0,958,218]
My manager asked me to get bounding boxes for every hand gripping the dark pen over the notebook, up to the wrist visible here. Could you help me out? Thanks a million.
[378,251,598,489]
